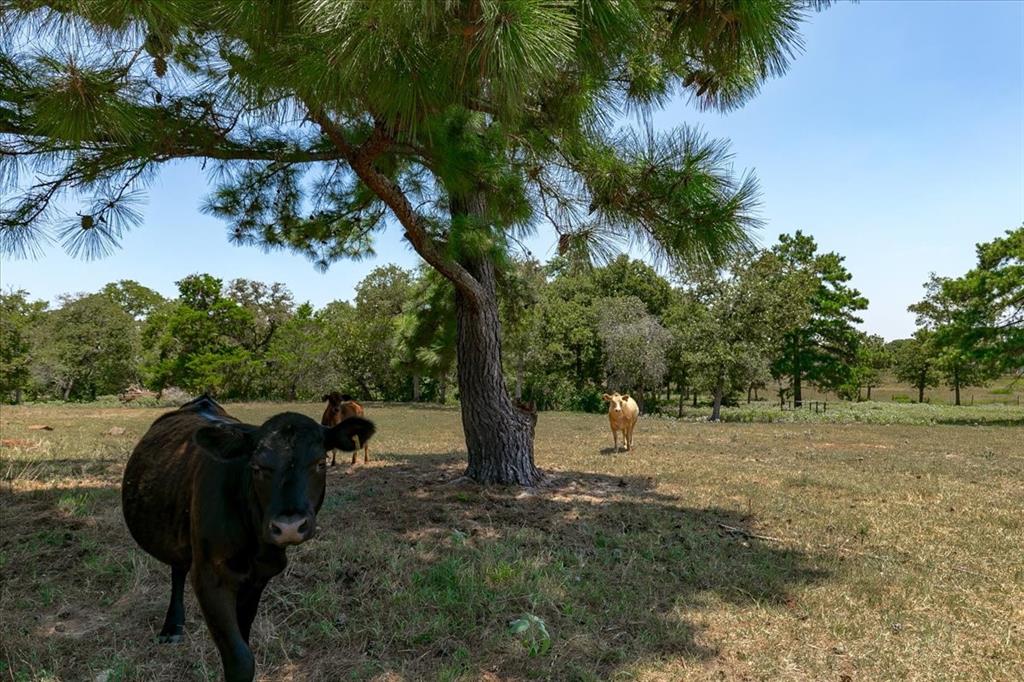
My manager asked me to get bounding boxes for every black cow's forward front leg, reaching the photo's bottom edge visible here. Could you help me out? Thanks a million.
[193,569,256,682]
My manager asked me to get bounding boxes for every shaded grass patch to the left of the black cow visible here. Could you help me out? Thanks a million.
[0,481,230,681]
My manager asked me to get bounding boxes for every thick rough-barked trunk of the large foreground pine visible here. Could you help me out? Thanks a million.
[455,254,541,485]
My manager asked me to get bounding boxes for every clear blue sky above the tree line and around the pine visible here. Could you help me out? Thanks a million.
[0,0,1024,339]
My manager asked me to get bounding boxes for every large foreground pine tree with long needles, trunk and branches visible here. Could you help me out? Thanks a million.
[6,0,827,484]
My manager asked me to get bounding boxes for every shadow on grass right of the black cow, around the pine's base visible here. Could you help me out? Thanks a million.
[282,453,827,679]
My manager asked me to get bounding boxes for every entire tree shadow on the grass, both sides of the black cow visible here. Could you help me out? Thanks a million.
[0,452,827,680]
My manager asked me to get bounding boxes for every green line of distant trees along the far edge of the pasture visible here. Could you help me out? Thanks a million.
[0,228,1024,411]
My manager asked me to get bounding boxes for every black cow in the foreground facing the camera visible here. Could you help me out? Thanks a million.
[121,396,374,682]
